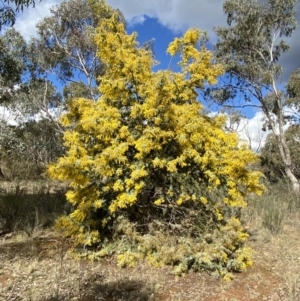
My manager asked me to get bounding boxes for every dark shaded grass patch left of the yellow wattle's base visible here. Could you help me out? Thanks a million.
[0,181,70,236]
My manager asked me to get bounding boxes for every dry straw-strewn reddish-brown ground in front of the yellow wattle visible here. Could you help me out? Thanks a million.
[0,211,300,301]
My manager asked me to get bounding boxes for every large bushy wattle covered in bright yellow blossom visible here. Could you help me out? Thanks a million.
[49,1,263,277]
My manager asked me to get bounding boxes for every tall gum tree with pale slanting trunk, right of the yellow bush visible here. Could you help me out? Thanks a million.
[208,0,299,192]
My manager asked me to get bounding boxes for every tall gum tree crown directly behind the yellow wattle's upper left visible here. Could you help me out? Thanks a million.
[30,0,125,101]
